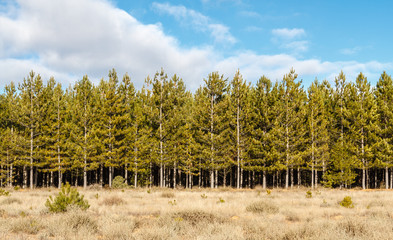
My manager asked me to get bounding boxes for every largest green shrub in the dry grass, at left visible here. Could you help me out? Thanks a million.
[45,183,90,213]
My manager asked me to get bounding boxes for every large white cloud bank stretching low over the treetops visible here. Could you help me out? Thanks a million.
[0,0,393,90]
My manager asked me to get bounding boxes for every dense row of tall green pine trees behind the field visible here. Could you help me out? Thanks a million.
[0,69,393,189]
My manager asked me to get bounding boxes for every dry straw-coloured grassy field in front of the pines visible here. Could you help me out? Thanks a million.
[0,188,393,240]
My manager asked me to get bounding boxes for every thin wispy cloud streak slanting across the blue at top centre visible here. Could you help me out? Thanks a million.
[152,2,236,44]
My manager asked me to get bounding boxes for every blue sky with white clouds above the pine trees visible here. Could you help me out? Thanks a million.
[0,0,393,91]
